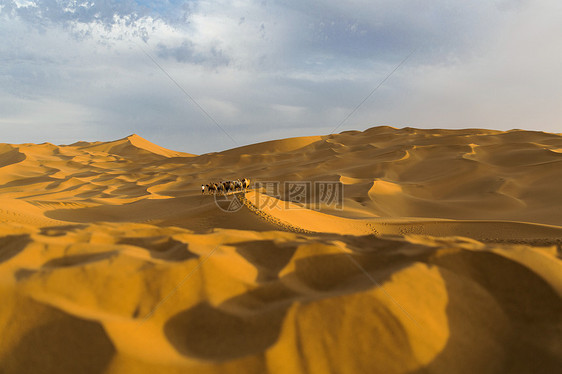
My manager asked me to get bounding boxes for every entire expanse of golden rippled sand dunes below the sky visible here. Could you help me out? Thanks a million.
[0,126,562,373]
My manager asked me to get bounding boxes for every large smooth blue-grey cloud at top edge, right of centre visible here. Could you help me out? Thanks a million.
[270,0,516,64]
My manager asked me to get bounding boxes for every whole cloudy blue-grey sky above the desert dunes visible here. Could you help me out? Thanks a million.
[0,0,562,154]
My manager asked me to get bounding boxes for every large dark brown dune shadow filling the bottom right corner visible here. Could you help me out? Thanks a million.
[406,251,562,374]
